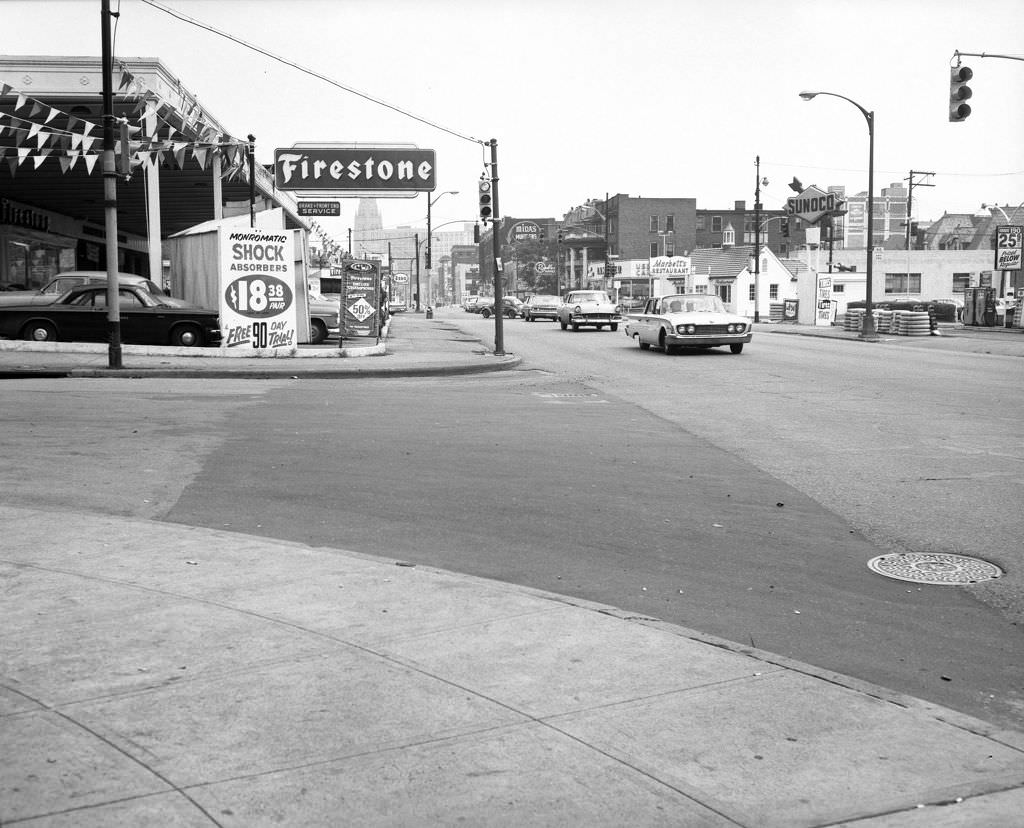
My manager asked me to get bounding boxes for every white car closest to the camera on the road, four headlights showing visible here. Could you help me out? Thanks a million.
[626,294,753,354]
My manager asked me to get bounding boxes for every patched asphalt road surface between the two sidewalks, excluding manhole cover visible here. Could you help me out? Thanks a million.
[8,317,1024,727]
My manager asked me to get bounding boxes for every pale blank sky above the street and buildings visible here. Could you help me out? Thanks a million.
[0,0,1024,244]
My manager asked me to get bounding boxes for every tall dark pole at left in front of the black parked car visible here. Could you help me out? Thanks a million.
[99,0,122,368]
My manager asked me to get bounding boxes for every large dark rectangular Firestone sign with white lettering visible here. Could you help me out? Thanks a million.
[273,144,437,192]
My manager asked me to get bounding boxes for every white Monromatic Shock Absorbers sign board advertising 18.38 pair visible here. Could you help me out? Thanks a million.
[220,228,298,356]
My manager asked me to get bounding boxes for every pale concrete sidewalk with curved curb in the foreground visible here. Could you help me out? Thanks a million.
[0,508,1024,828]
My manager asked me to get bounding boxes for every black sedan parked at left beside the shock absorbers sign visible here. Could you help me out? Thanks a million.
[0,285,220,347]
